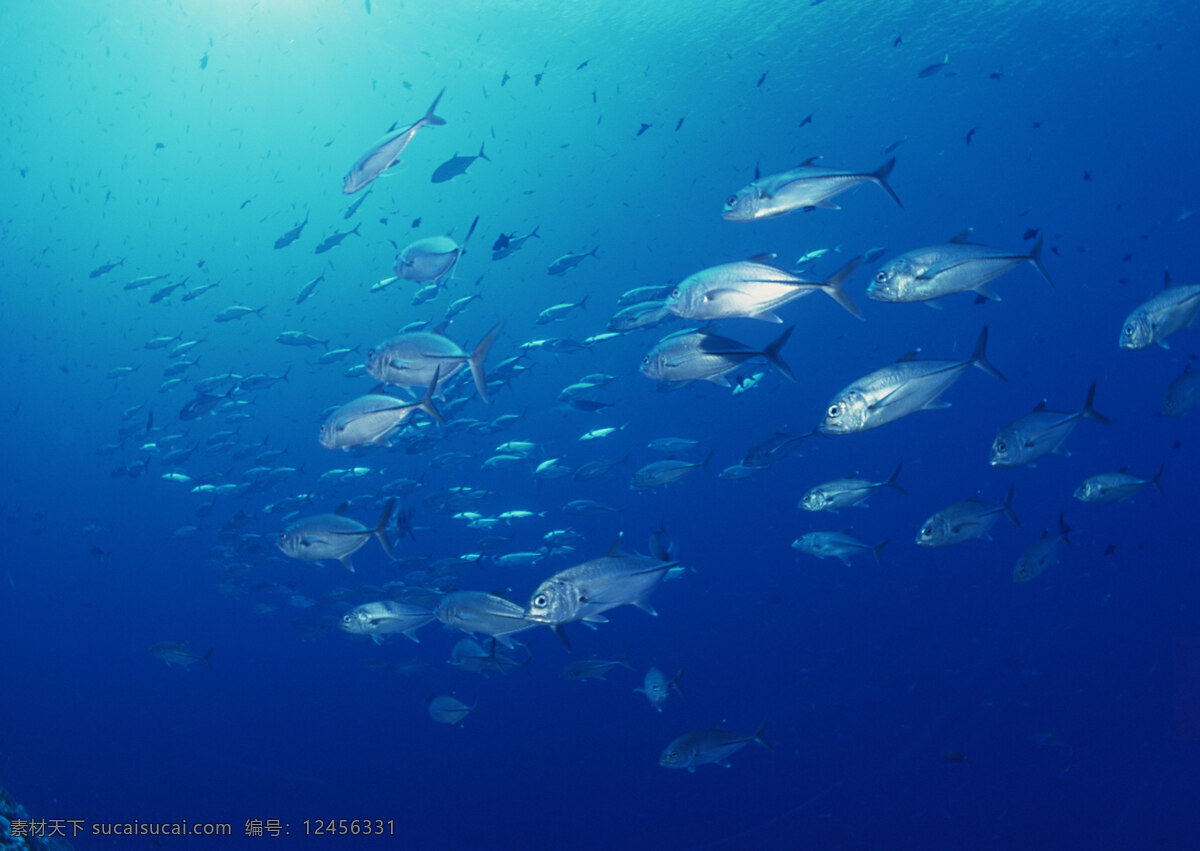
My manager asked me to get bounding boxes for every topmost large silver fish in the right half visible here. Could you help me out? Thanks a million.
[721,157,904,222]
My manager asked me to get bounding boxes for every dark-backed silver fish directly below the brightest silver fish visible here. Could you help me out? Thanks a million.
[638,325,796,388]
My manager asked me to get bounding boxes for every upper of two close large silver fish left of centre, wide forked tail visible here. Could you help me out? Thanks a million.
[367,322,504,403]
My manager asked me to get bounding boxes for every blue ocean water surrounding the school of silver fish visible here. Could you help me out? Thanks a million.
[0,0,1200,849]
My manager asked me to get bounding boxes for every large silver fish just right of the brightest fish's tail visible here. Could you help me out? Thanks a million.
[866,229,1054,302]
